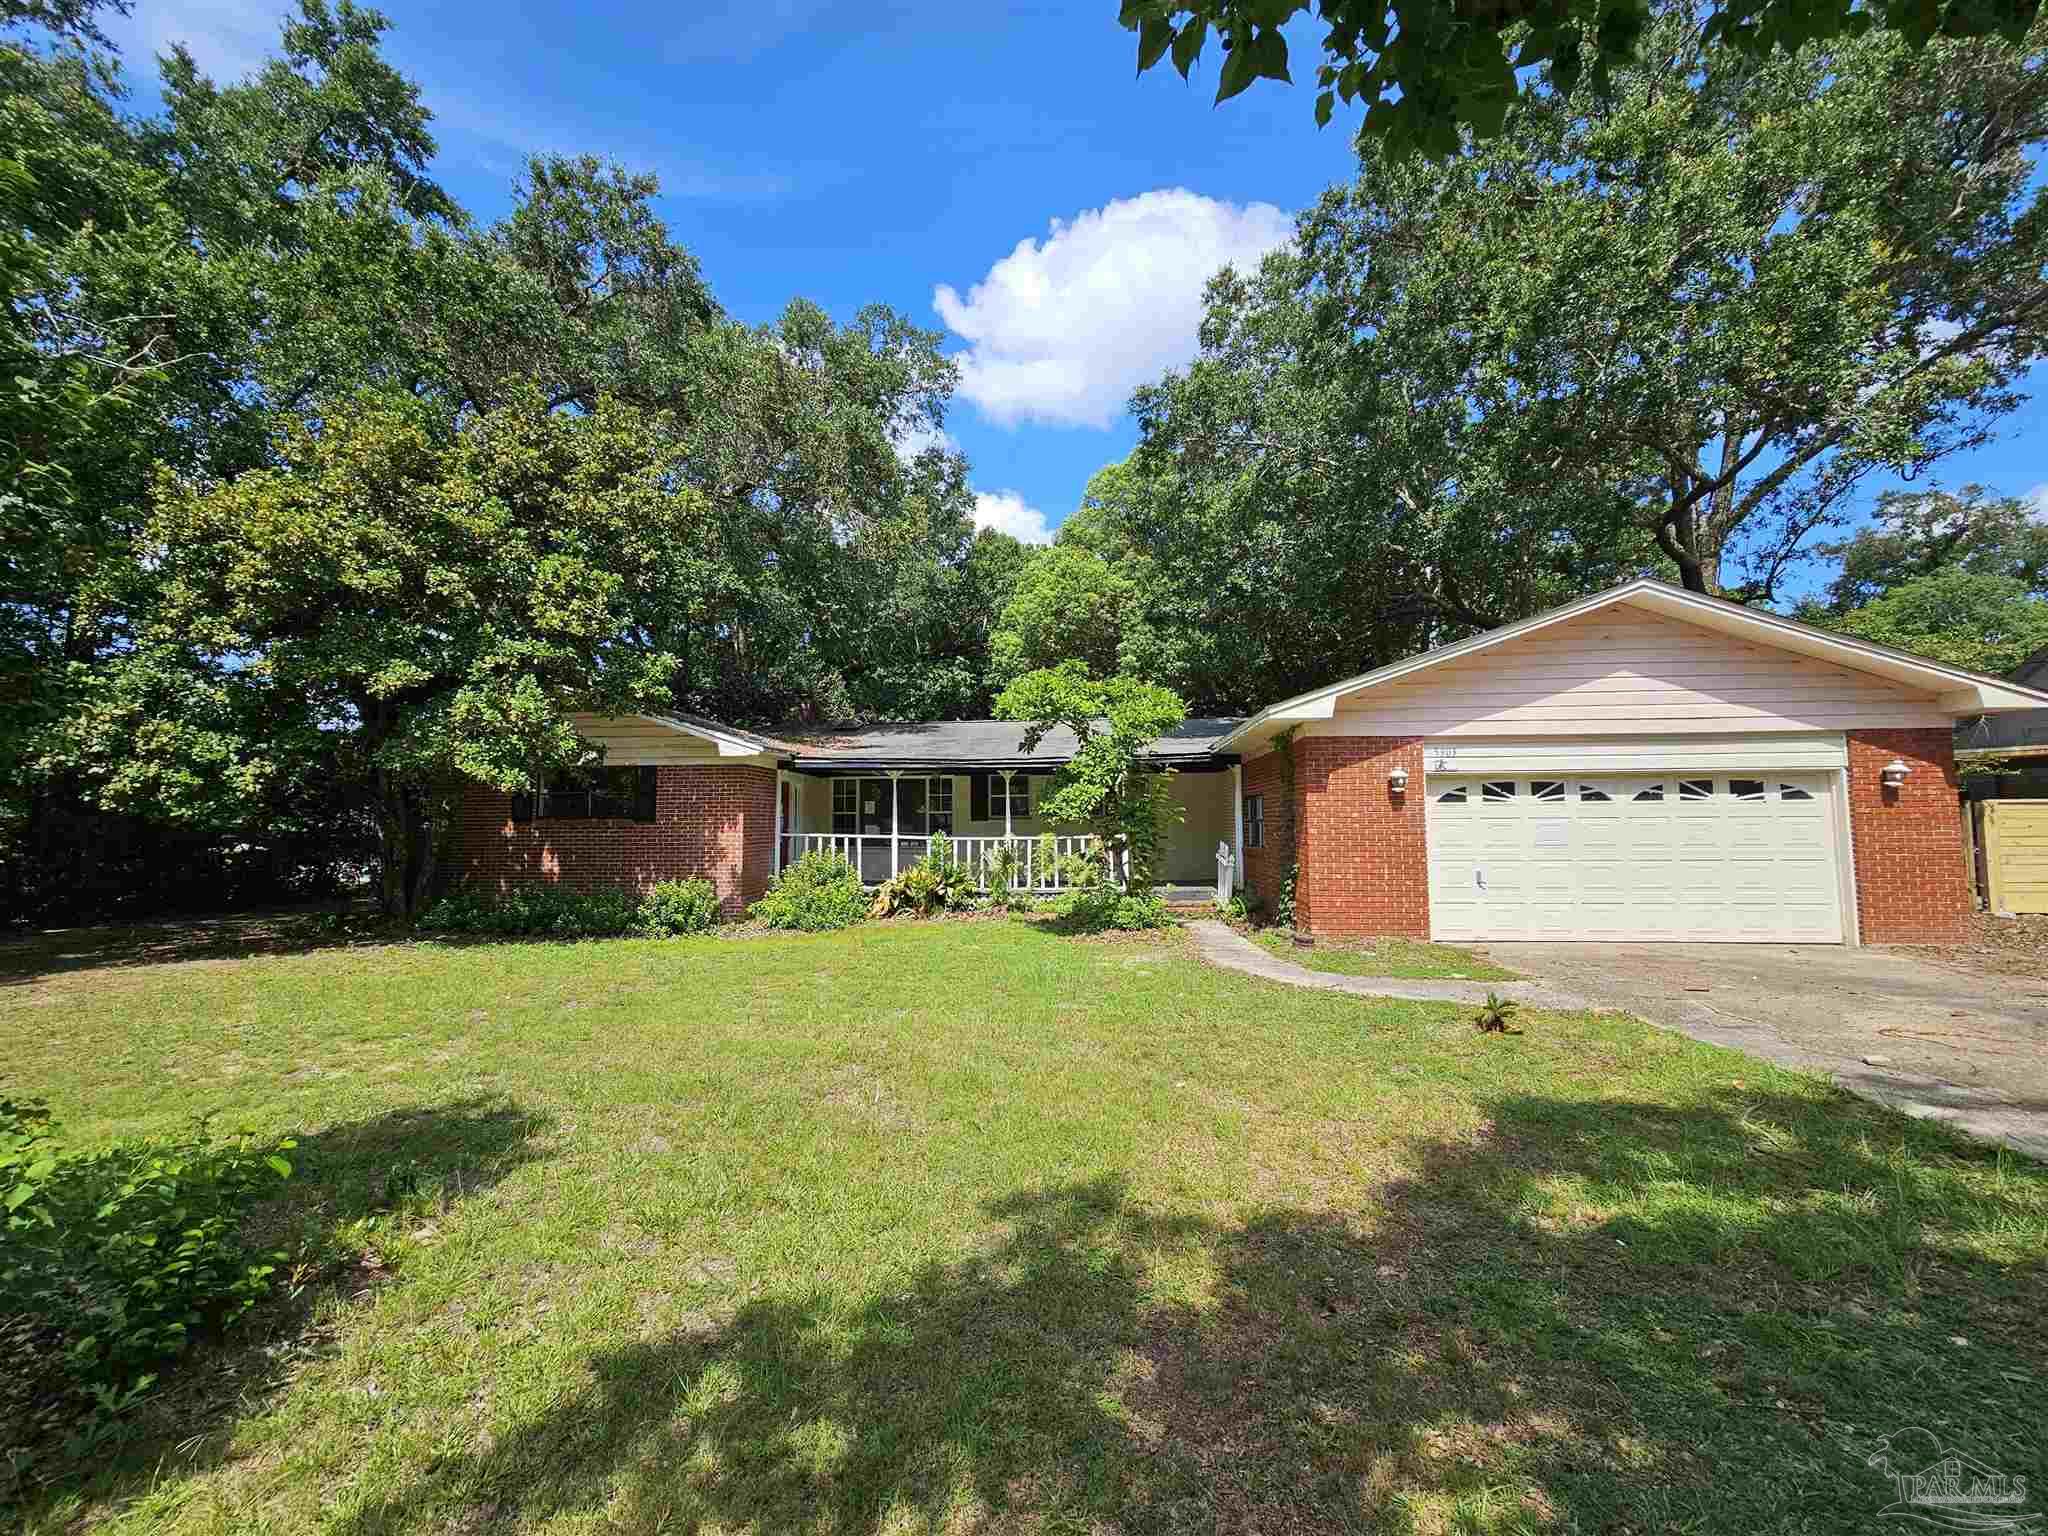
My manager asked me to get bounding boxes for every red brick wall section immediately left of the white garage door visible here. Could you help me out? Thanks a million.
[1294,735,1430,938]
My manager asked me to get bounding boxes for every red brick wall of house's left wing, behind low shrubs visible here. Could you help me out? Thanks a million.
[453,764,774,918]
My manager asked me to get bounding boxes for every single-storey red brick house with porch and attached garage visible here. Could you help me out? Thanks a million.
[455,580,2048,944]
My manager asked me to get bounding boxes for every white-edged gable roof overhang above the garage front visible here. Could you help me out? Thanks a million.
[1217,575,2048,752]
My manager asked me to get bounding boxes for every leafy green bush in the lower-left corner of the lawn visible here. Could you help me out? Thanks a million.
[0,1100,295,1477]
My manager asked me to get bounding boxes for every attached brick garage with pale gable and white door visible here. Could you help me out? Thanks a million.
[1221,580,2048,944]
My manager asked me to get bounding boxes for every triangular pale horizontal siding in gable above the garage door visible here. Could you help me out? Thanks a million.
[1307,606,1952,737]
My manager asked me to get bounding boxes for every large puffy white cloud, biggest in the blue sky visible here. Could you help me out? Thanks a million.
[932,186,1292,428]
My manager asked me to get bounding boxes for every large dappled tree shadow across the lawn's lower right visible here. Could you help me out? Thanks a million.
[338,1096,2048,1536]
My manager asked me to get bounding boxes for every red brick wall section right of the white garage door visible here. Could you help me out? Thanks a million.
[1849,729,1974,944]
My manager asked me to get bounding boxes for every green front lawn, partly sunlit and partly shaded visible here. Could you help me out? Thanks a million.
[0,922,2048,1536]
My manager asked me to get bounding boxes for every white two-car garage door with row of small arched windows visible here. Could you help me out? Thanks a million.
[1425,772,1841,944]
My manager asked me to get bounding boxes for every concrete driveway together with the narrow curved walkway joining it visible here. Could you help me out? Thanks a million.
[1188,920,2048,1161]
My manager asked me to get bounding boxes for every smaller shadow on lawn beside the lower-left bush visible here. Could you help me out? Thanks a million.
[16,1096,549,1509]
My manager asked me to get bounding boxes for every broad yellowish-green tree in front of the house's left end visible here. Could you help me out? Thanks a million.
[137,395,721,915]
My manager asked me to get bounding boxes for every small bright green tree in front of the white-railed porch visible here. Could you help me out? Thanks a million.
[995,662,1188,889]
